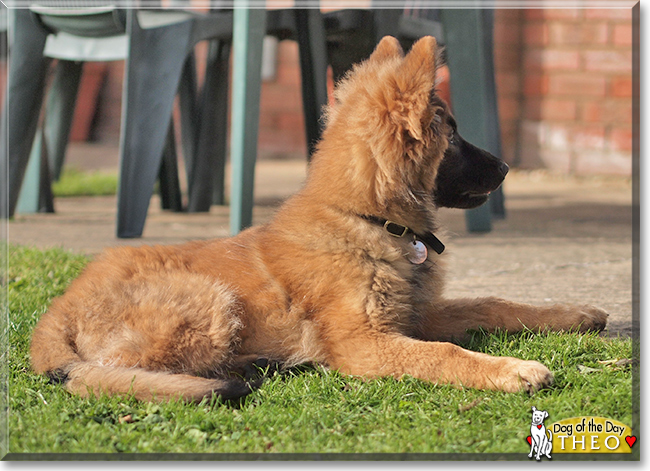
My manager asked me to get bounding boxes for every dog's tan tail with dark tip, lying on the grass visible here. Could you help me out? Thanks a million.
[31,312,253,401]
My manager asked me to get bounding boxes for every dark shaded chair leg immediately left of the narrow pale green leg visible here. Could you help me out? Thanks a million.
[188,40,230,212]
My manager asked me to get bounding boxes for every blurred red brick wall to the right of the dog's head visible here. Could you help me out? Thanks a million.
[504,9,632,175]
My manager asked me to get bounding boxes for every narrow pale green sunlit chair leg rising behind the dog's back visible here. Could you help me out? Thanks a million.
[230,8,266,235]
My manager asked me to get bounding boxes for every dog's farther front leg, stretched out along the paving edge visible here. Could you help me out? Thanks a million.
[415,297,608,340]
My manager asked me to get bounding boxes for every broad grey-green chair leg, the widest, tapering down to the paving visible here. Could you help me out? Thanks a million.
[117,10,192,238]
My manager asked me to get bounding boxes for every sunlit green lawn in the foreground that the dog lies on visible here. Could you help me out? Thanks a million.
[6,246,638,460]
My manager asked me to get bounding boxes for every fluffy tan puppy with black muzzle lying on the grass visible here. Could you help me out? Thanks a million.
[31,37,607,400]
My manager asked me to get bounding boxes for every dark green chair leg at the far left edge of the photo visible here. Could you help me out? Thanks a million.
[0,9,50,217]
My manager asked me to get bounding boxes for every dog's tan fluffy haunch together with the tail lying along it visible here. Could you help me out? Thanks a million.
[31,272,246,400]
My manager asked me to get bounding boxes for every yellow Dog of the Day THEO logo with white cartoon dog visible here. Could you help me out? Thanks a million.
[526,407,637,461]
